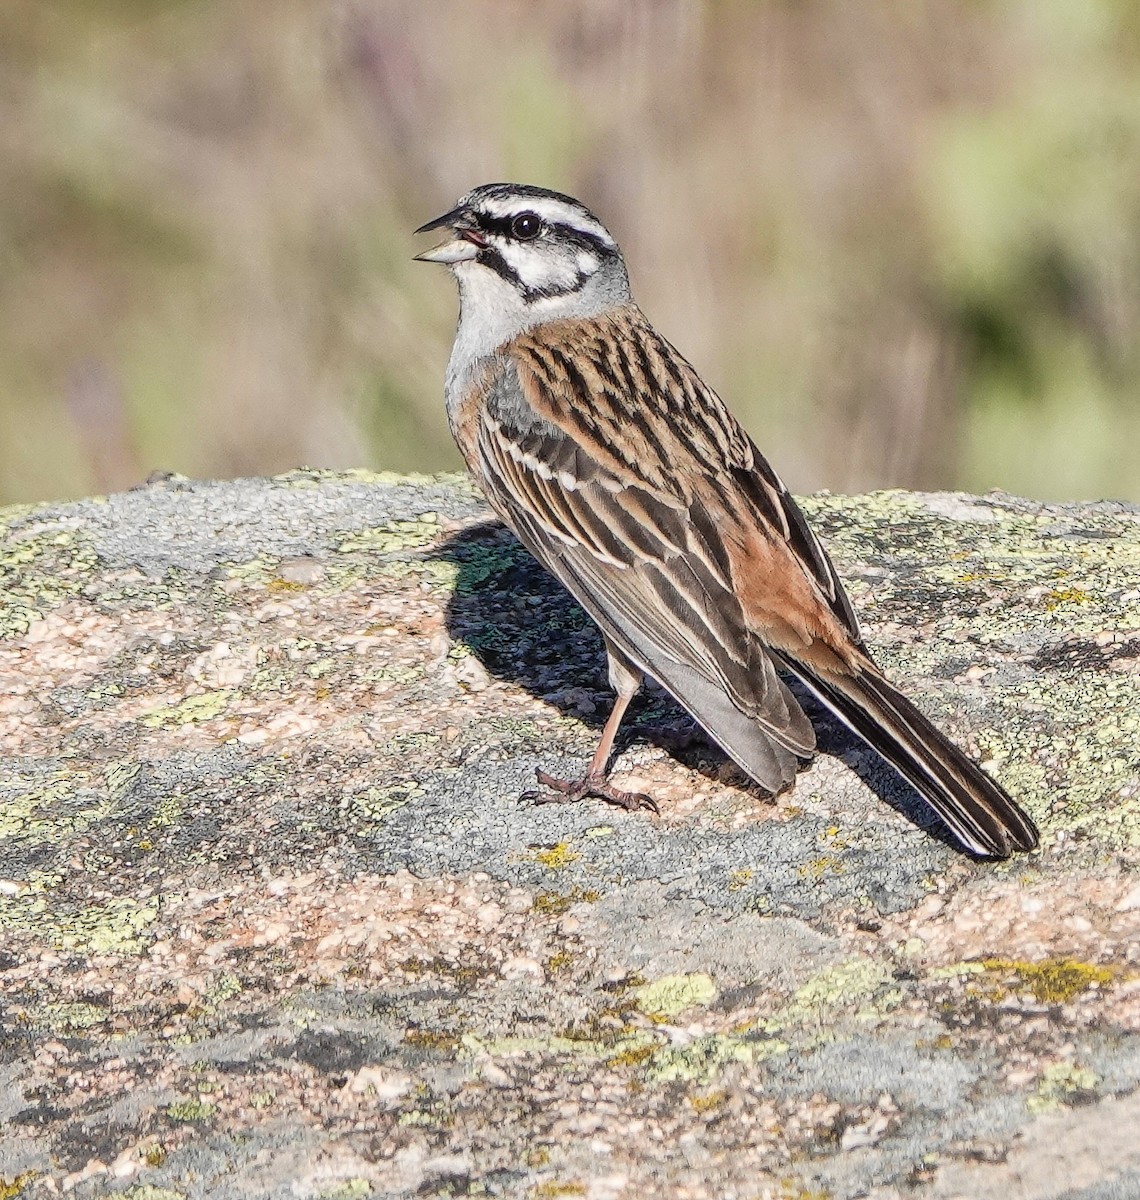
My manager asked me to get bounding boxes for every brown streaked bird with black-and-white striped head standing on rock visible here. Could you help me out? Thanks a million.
[415,182,1038,858]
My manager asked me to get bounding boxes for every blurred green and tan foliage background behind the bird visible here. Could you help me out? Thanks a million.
[0,0,1140,502]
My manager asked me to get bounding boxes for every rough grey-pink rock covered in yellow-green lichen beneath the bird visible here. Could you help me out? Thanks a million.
[0,472,1140,1200]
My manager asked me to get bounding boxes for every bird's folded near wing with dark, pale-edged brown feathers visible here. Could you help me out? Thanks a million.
[476,355,815,791]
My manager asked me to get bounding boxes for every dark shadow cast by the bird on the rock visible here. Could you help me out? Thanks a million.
[431,521,961,851]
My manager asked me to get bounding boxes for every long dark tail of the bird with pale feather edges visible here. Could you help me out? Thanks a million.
[781,655,1038,858]
